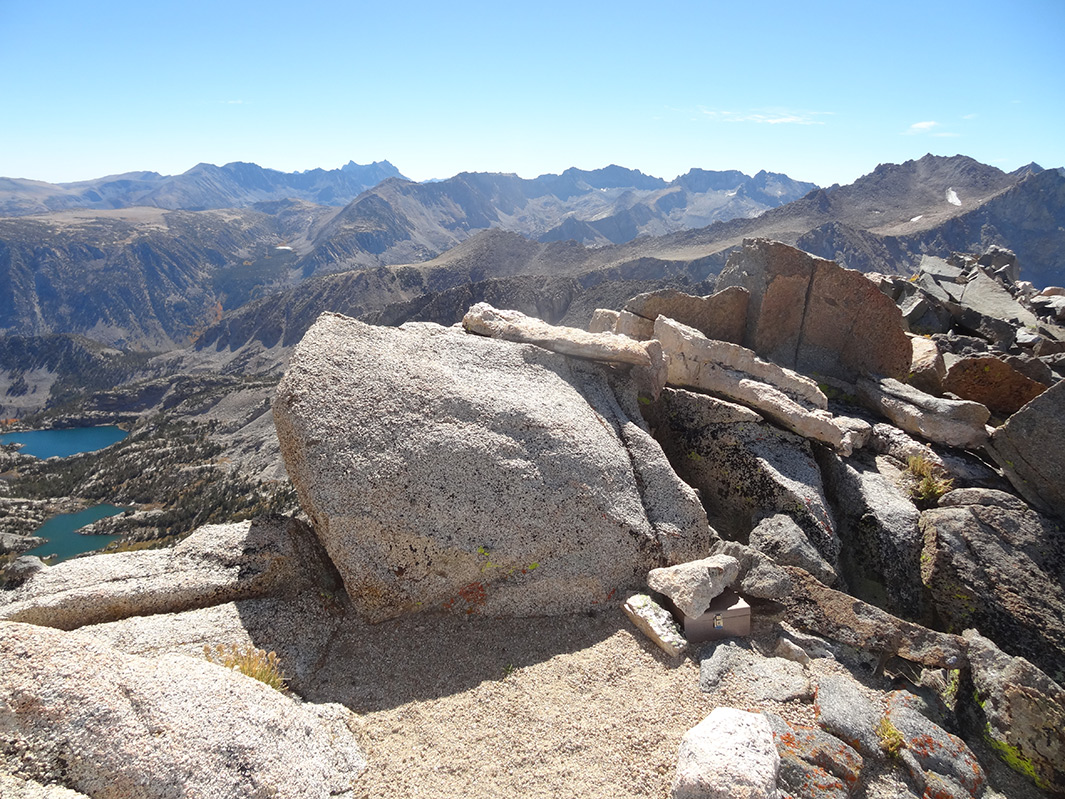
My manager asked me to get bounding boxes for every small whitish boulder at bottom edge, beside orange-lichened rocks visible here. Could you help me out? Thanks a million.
[671,707,781,799]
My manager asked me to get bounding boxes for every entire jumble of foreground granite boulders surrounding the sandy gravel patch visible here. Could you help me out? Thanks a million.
[0,240,1065,799]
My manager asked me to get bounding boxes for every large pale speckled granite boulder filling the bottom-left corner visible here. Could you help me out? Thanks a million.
[0,622,366,799]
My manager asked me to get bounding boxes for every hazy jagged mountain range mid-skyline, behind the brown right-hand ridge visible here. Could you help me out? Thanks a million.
[304,165,817,276]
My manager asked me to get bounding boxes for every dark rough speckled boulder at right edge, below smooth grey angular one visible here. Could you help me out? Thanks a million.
[920,488,1065,671]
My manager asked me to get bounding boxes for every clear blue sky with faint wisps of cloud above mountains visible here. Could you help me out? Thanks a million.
[0,0,1065,185]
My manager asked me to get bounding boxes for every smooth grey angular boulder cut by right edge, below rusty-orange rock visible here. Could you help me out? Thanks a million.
[989,382,1065,519]
